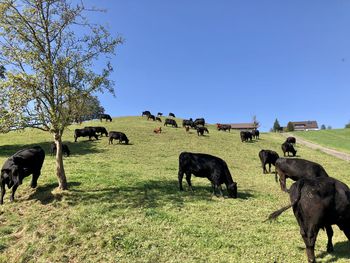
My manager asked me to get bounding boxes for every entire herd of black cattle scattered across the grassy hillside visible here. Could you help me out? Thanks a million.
[0,112,350,262]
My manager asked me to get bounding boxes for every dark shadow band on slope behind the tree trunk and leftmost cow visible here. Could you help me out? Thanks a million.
[0,140,101,157]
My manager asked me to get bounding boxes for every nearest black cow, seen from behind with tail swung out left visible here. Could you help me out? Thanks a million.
[269,177,350,263]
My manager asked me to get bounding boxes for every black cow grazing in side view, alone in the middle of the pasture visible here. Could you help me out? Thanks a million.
[178,152,237,198]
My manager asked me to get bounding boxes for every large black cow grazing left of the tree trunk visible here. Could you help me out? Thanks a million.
[0,146,45,205]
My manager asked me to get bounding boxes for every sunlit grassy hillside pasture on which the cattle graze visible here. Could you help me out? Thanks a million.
[0,117,350,263]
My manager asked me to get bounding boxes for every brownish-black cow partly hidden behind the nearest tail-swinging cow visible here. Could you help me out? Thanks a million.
[275,158,328,191]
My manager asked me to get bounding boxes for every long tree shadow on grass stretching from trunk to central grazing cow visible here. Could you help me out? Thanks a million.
[28,180,253,208]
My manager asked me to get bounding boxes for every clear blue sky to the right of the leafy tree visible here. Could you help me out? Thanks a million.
[86,0,350,131]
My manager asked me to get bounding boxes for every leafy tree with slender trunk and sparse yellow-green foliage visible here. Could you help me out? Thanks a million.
[0,0,122,189]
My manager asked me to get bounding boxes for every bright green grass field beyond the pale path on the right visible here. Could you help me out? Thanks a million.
[294,129,350,153]
